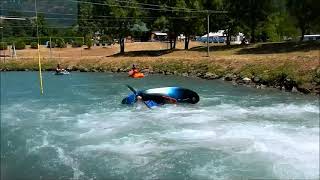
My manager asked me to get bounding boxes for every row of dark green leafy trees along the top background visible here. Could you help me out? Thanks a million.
[1,0,320,52]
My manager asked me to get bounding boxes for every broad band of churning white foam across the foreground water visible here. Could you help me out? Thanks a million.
[1,89,319,179]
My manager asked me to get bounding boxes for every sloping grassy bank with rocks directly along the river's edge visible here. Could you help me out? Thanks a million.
[0,56,320,94]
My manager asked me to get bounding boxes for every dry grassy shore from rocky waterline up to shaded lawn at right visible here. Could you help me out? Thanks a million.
[0,42,320,95]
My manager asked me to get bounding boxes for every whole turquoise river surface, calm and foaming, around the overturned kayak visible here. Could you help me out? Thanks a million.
[1,72,319,180]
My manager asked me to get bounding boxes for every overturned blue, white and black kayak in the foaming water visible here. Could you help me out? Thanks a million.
[122,87,200,106]
